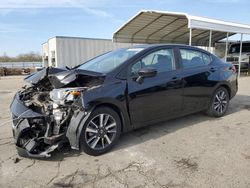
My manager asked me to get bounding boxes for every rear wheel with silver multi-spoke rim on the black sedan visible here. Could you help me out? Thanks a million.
[206,87,229,117]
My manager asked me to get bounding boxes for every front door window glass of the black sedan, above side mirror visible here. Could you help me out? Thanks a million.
[131,49,176,76]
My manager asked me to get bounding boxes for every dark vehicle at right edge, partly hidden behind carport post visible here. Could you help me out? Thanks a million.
[227,42,250,72]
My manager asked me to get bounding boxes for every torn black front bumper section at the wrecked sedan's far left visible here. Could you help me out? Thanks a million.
[10,93,49,157]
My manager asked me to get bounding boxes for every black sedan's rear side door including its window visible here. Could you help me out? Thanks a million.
[179,47,216,114]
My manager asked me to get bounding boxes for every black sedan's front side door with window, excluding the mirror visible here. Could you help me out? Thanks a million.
[128,48,182,127]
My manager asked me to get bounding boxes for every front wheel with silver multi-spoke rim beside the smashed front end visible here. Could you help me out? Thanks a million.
[80,106,121,156]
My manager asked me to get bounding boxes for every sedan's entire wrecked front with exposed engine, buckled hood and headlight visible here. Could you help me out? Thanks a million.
[11,68,102,157]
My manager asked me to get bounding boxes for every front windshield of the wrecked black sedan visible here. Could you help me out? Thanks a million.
[78,48,143,73]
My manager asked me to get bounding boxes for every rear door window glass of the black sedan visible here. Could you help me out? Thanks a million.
[180,49,211,68]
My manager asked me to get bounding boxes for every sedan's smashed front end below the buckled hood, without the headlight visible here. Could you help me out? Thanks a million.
[11,88,84,157]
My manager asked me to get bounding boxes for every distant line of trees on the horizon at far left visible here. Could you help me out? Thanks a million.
[0,52,42,62]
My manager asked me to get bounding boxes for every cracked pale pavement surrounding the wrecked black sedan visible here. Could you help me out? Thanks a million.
[0,76,250,188]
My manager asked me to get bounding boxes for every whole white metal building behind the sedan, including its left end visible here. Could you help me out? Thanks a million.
[42,36,131,67]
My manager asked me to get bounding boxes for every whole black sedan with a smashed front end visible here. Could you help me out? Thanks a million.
[10,45,238,157]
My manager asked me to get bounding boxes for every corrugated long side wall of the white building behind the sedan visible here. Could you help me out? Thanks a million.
[55,37,131,67]
